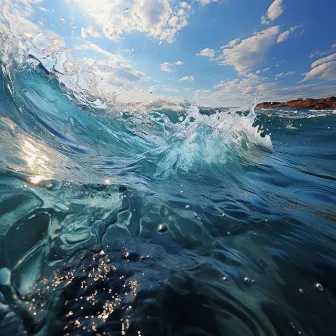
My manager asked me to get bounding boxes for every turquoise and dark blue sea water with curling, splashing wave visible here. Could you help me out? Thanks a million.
[0,62,336,336]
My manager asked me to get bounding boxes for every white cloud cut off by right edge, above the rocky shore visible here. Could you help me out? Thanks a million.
[302,53,336,82]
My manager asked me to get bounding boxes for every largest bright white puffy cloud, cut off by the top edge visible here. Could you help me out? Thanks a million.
[74,0,191,43]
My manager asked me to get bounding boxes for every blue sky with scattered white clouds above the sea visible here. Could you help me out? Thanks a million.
[0,0,336,106]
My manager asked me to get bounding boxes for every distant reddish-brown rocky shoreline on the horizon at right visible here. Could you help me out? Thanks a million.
[256,97,336,110]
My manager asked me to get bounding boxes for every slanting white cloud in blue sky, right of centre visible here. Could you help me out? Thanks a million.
[217,26,280,75]
